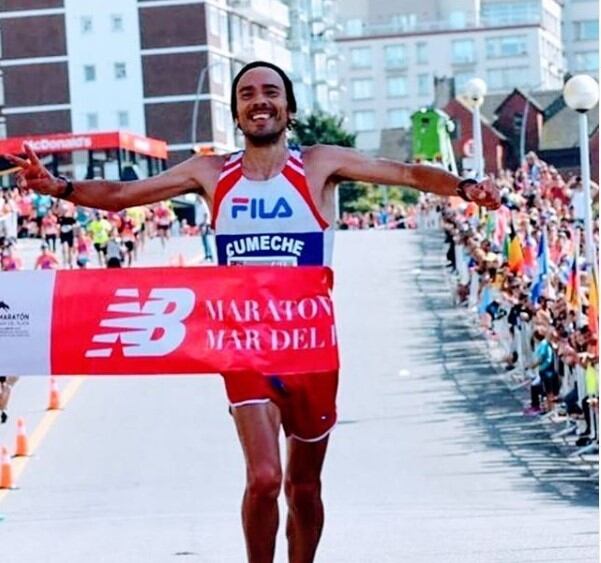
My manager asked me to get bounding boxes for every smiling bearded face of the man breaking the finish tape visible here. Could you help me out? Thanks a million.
[236,67,291,146]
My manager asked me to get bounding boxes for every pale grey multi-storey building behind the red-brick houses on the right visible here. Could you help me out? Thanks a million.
[337,0,577,152]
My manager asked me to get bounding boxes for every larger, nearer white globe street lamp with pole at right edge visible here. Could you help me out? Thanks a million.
[563,74,599,267]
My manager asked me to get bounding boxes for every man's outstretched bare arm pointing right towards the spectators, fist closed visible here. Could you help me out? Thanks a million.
[314,145,501,209]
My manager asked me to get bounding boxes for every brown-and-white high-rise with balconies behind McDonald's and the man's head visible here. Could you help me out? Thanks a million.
[0,0,333,167]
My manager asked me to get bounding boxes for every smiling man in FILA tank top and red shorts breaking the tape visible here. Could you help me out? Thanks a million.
[10,61,500,563]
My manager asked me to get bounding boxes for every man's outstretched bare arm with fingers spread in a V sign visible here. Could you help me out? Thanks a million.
[6,145,210,211]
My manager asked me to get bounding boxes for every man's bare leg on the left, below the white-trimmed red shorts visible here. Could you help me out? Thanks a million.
[232,403,282,563]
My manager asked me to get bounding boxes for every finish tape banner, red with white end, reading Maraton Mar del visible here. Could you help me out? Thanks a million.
[0,267,339,375]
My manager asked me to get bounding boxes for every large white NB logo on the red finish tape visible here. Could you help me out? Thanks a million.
[86,288,196,358]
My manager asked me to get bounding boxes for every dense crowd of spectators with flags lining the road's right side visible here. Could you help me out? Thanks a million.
[442,153,599,446]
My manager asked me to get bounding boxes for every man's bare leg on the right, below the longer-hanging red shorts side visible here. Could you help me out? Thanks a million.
[284,436,328,563]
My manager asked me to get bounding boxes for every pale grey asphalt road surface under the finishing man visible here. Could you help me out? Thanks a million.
[0,231,599,563]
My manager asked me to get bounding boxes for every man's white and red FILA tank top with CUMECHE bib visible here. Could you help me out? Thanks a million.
[212,148,334,266]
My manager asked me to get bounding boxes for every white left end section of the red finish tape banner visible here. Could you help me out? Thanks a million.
[0,271,56,375]
